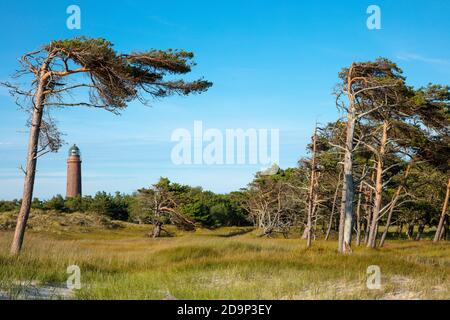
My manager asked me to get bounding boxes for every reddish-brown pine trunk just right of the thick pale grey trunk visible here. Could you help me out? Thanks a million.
[367,120,389,248]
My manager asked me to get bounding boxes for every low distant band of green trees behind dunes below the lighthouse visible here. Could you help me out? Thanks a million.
[0,186,250,228]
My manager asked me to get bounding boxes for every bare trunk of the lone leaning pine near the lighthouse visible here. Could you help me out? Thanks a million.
[11,75,47,255]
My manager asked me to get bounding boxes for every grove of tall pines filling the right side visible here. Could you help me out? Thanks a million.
[243,59,450,252]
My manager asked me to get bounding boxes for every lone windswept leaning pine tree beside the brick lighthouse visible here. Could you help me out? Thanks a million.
[3,37,212,254]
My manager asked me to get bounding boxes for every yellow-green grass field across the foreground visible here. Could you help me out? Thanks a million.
[0,215,450,299]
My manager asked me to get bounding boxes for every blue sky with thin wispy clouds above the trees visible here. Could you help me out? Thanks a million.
[0,0,450,199]
